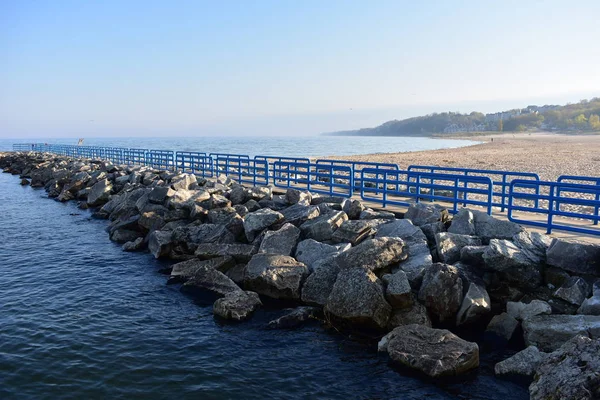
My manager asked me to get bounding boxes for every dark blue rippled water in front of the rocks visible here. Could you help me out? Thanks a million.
[0,174,528,400]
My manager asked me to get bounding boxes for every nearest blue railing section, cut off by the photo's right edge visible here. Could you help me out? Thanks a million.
[507,179,600,235]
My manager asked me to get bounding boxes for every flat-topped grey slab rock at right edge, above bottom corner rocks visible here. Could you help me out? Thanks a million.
[523,315,600,351]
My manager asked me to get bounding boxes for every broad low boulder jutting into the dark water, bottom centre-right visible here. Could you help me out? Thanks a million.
[387,325,479,378]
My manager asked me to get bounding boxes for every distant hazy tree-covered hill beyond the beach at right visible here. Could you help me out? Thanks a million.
[325,97,600,136]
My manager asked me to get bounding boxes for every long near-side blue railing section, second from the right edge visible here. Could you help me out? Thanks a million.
[360,168,493,215]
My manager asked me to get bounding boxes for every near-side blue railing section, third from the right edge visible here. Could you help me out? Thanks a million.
[273,161,354,198]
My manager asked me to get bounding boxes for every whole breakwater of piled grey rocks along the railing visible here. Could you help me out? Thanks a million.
[0,153,600,399]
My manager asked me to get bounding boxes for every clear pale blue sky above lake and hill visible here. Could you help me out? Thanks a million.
[0,0,600,138]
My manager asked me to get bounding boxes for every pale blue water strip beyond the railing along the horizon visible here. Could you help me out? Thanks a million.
[0,136,478,157]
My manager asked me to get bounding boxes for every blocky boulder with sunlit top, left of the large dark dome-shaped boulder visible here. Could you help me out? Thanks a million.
[244,254,309,300]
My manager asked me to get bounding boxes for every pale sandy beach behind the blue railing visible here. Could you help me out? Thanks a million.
[331,133,600,180]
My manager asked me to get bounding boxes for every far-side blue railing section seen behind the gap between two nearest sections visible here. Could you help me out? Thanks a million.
[407,165,540,211]
